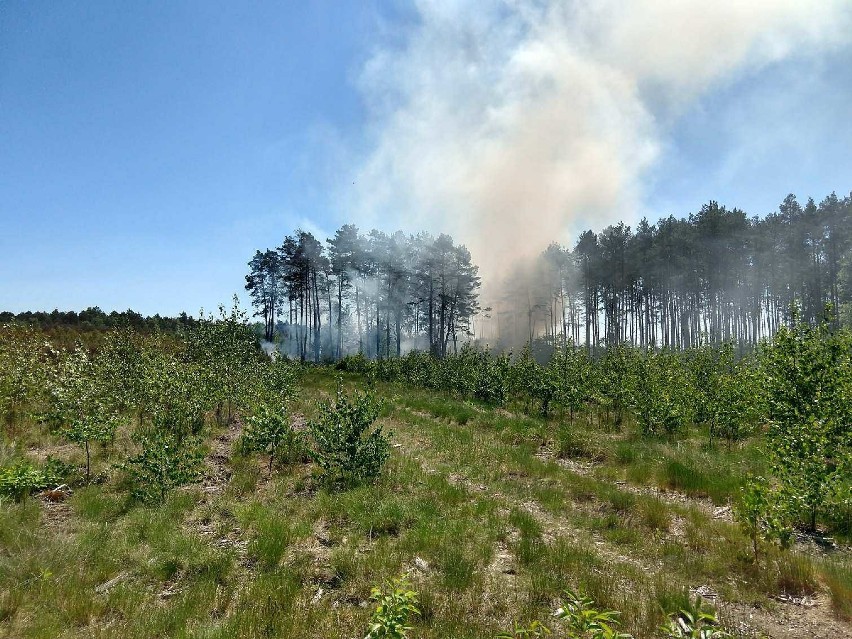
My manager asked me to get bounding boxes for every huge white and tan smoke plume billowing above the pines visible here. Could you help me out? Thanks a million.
[356,0,852,288]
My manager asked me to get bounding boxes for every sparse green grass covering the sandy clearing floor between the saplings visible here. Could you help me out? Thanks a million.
[0,369,852,638]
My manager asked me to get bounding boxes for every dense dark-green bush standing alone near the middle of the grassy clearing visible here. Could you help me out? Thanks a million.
[308,384,390,486]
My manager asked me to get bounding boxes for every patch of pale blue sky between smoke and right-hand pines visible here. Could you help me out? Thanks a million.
[649,46,852,216]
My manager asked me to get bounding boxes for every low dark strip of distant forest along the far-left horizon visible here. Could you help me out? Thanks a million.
[0,306,196,333]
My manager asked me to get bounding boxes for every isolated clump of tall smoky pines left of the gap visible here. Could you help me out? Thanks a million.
[246,224,480,361]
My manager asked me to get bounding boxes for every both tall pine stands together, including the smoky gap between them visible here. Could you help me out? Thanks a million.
[246,193,852,361]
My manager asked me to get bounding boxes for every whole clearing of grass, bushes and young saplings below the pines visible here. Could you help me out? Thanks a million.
[0,309,852,639]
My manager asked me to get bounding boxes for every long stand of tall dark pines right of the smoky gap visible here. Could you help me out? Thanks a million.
[506,193,852,348]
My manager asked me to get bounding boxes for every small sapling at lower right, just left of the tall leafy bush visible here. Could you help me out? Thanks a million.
[734,477,793,561]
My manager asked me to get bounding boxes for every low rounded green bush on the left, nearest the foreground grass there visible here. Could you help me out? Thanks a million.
[123,429,204,502]
